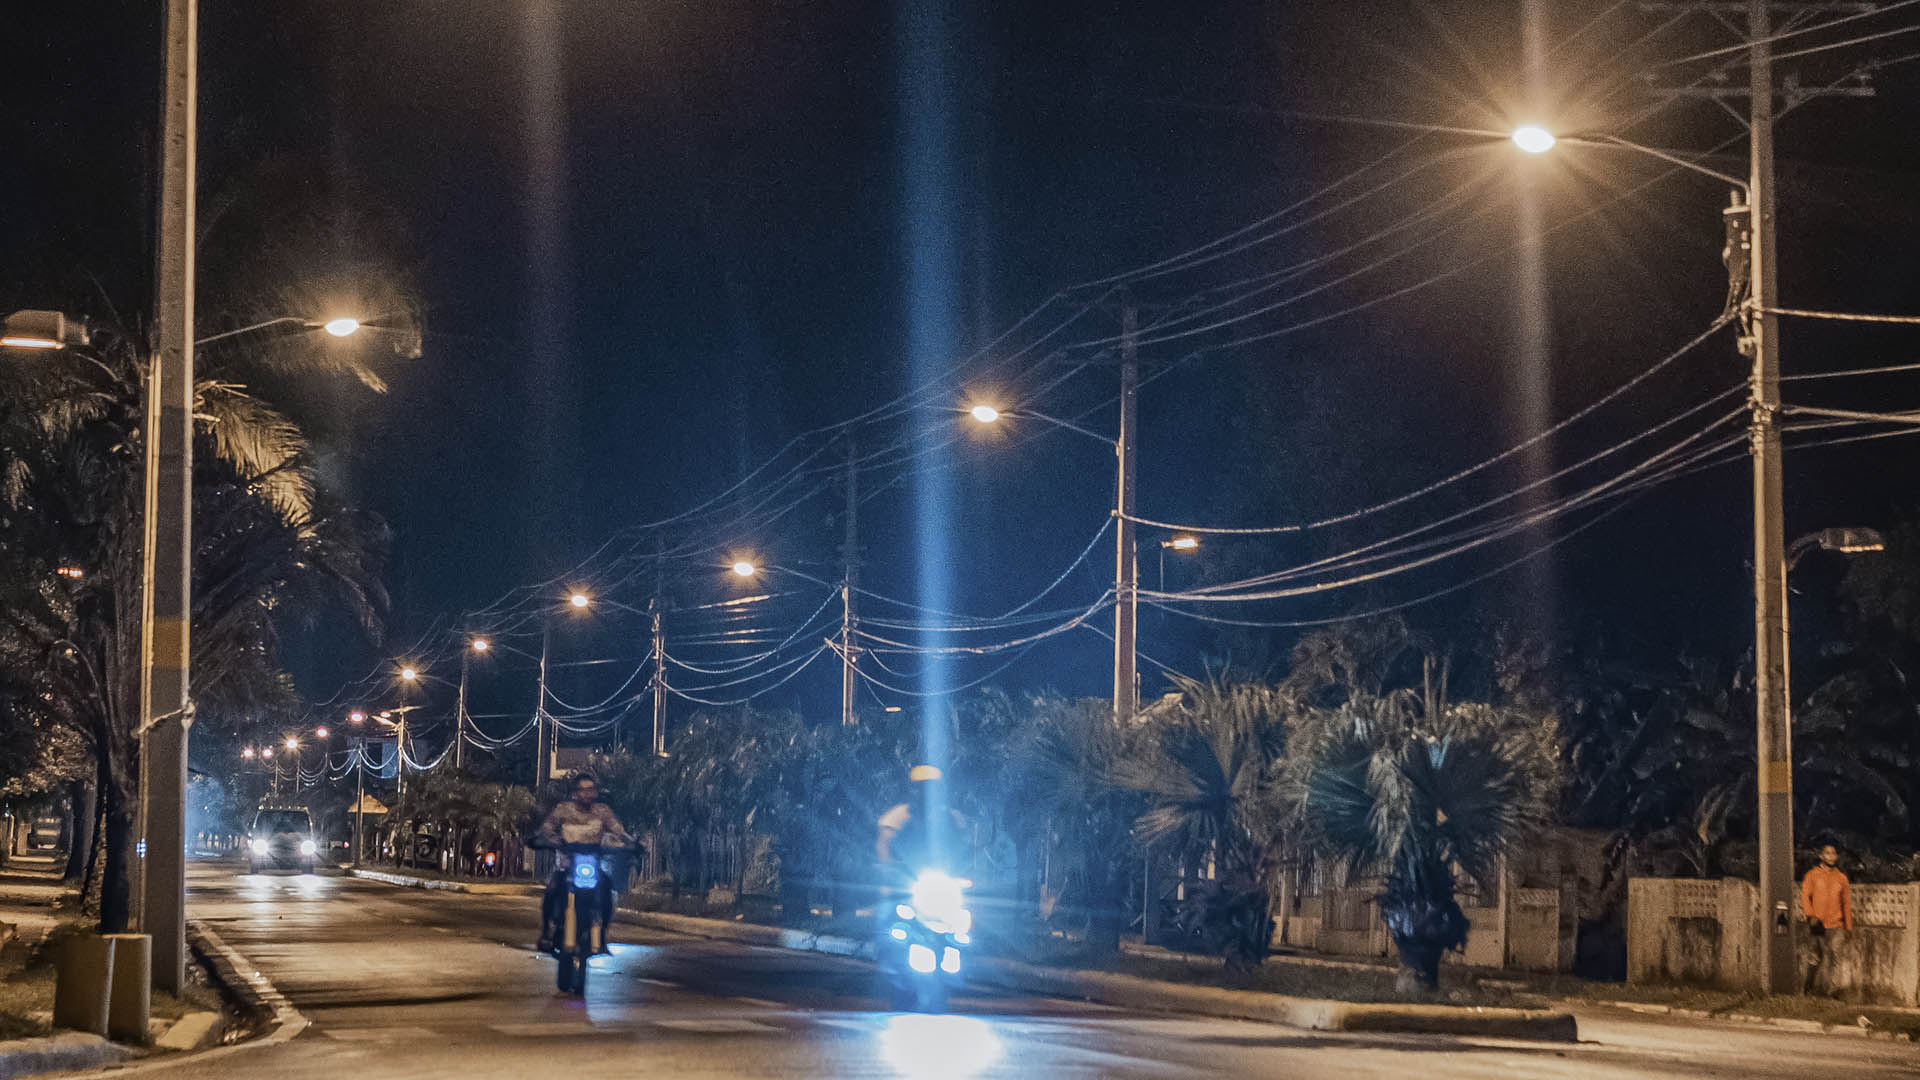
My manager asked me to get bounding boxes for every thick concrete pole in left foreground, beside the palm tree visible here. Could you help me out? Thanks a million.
[138,0,198,992]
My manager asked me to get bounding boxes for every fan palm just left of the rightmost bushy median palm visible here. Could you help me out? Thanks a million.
[1112,675,1286,967]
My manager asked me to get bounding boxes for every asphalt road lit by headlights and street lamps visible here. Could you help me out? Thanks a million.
[97,863,1920,1080]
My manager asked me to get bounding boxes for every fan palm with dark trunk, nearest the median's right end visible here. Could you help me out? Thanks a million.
[1286,665,1561,990]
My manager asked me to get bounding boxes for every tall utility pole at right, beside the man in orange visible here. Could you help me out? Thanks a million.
[1741,0,1799,994]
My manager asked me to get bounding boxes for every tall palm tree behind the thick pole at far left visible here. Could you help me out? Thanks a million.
[0,319,384,932]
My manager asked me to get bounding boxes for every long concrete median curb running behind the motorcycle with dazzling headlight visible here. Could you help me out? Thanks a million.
[622,909,1580,1042]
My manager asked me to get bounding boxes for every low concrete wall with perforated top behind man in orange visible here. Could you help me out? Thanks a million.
[1626,878,1920,1005]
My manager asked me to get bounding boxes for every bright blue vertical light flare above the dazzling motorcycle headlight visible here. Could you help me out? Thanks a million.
[895,0,964,857]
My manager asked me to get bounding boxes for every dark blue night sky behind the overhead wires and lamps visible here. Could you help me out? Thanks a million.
[11,0,1920,734]
